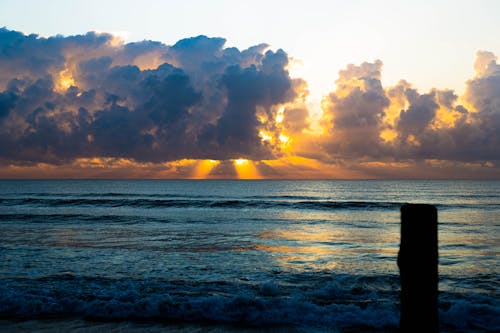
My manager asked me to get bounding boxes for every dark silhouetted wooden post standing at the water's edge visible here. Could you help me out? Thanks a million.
[398,204,439,332]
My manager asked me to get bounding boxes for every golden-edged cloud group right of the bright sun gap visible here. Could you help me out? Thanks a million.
[318,51,500,167]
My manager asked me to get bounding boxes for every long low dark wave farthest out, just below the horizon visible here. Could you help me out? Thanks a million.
[0,197,403,210]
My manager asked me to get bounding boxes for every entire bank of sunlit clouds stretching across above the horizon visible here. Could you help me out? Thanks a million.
[0,28,500,178]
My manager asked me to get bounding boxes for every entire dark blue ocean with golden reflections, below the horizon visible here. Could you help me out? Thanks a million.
[0,180,500,332]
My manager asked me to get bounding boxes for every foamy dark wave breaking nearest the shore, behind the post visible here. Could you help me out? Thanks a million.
[0,272,500,332]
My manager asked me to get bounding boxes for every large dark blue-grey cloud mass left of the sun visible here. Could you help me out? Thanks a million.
[0,28,298,164]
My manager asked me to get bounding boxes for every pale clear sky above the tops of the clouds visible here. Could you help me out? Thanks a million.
[0,0,500,97]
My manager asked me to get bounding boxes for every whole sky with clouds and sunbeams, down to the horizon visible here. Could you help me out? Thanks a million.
[0,0,500,178]
